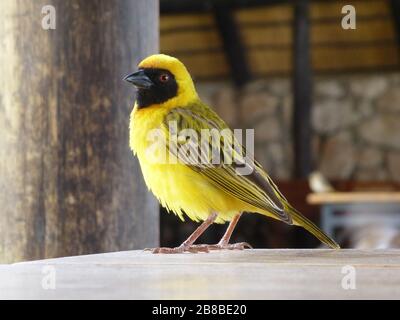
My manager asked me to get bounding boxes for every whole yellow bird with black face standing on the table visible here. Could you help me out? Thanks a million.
[124,54,339,253]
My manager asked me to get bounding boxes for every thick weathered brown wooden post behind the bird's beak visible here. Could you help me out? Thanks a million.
[0,0,159,263]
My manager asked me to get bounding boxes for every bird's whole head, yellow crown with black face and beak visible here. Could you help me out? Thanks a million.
[125,54,198,109]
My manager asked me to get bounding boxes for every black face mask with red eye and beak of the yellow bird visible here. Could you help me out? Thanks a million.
[124,68,178,108]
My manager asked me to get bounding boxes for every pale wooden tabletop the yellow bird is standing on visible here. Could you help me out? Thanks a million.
[0,249,400,299]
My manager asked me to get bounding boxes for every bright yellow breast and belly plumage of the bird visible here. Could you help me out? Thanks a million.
[130,105,244,223]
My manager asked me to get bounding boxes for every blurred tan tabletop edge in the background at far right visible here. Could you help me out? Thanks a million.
[307,191,400,205]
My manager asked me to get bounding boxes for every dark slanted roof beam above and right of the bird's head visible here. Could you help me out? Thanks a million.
[214,5,251,86]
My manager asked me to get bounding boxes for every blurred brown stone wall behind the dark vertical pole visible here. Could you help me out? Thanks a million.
[197,73,400,181]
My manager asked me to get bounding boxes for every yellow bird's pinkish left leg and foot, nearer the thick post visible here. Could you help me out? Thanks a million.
[145,213,217,253]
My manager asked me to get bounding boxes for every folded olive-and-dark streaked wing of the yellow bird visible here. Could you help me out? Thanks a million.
[164,102,292,224]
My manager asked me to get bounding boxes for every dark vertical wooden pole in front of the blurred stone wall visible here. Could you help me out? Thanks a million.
[293,0,312,178]
